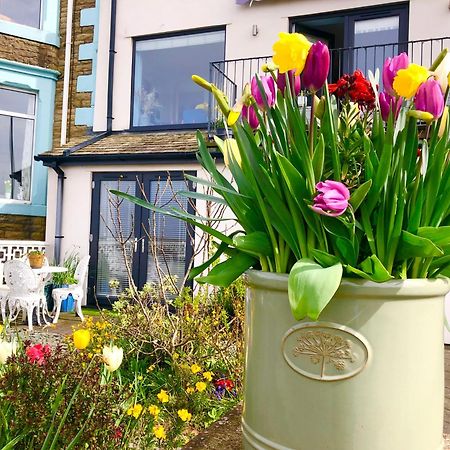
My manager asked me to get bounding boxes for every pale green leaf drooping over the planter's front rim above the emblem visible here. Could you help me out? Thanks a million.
[288,258,342,320]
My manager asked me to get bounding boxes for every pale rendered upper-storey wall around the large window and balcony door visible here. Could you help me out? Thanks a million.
[94,0,450,134]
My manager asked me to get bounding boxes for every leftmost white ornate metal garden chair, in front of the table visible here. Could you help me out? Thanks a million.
[4,260,41,331]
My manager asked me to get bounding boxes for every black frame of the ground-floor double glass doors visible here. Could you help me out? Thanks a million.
[87,171,196,307]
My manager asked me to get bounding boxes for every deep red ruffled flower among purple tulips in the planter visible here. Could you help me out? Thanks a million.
[328,70,375,109]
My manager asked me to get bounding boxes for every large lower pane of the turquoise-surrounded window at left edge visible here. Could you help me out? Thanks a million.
[0,115,34,201]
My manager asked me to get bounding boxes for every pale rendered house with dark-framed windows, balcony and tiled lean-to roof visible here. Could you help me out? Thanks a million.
[38,0,450,302]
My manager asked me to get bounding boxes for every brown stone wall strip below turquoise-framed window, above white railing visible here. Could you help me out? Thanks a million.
[0,214,45,241]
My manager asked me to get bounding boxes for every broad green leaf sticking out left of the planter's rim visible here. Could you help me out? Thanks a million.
[196,252,257,287]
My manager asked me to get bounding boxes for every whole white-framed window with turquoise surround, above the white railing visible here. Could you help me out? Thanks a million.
[0,88,36,201]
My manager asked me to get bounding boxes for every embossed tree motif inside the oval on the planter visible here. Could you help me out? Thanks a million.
[293,331,354,378]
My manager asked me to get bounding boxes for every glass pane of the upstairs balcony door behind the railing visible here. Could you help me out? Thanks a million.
[354,16,400,75]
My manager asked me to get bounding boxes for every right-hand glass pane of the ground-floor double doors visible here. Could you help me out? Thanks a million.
[147,180,187,287]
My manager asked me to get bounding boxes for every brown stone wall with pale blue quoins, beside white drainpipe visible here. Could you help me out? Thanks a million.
[53,0,95,147]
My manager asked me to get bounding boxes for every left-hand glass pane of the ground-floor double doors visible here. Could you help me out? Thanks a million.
[96,181,136,296]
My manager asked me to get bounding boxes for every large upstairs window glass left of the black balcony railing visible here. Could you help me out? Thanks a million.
[131,30,225,128]
